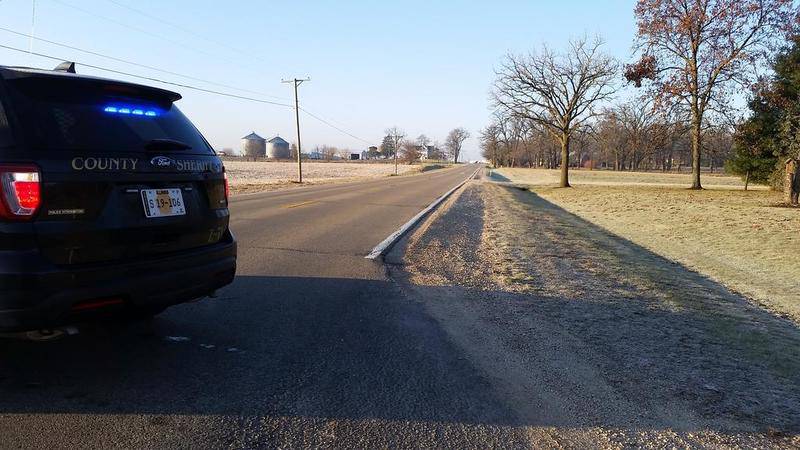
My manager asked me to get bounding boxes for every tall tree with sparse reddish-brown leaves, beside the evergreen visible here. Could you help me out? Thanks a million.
[625,0,797,189]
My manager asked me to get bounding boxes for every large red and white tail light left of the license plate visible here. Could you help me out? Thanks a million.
[0,165,42,220]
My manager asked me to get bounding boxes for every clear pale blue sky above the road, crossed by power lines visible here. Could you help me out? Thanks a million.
[0,0,635,159]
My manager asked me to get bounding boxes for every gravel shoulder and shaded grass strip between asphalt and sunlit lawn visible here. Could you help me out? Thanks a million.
[390,181,800,448]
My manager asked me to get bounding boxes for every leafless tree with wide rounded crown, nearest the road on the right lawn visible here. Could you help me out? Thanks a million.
[492,38,617,187]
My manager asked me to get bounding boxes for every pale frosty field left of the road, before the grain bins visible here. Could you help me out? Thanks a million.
[225,160,423,194]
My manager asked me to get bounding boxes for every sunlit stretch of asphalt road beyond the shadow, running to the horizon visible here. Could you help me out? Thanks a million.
[231,165,477,277]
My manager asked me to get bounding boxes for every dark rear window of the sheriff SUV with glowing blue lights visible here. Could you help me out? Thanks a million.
[3,78,213,154]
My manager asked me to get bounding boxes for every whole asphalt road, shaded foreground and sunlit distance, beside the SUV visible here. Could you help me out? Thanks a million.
[0,166,521,448]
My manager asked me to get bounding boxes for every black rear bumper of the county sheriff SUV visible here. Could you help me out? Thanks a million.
[0,234,236,332]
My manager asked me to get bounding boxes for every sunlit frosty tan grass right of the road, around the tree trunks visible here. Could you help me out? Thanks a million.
[496,169,800,321]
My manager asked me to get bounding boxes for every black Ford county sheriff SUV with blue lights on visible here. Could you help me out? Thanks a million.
[0,65,236,332]
